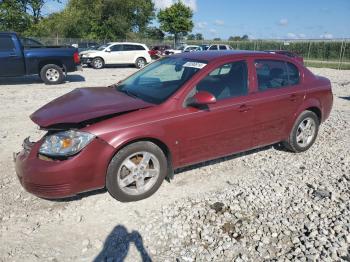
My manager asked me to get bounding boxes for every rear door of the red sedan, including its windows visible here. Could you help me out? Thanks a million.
[247,59,305,146]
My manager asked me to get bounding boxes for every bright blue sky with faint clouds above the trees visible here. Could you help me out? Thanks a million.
[44,0,350,39]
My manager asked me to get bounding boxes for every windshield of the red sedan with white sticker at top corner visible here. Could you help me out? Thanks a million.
[117,57,206,104]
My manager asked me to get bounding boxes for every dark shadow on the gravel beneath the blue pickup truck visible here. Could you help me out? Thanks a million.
[0,74,85,86]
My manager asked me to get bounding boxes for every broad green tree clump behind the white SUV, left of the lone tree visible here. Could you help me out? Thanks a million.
[31,0,154,40]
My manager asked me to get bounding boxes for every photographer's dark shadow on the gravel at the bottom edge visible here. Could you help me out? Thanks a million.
[93,225,152,262]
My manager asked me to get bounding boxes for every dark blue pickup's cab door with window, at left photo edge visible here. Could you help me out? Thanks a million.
[0,34,25,76]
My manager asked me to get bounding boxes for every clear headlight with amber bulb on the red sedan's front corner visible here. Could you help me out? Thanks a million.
[39,130,95,156]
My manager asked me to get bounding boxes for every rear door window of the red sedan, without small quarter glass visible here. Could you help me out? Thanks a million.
[255,60,289,91]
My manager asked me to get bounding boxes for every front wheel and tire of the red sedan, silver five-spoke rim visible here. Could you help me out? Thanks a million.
[106,141,168,202]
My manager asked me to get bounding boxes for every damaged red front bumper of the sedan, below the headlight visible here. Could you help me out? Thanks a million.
[13,135,115,199]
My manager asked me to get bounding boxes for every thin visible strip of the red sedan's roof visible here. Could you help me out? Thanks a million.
[172,50,270,62]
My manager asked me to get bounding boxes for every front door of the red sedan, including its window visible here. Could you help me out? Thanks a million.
[179,61,253,165]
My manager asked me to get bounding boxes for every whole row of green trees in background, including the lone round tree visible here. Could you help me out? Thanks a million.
[0,0,197,40]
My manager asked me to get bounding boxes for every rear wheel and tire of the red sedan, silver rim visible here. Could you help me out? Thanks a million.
[283,111,320,153]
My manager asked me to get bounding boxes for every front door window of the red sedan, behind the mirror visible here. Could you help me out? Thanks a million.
[196,61,248,100]
